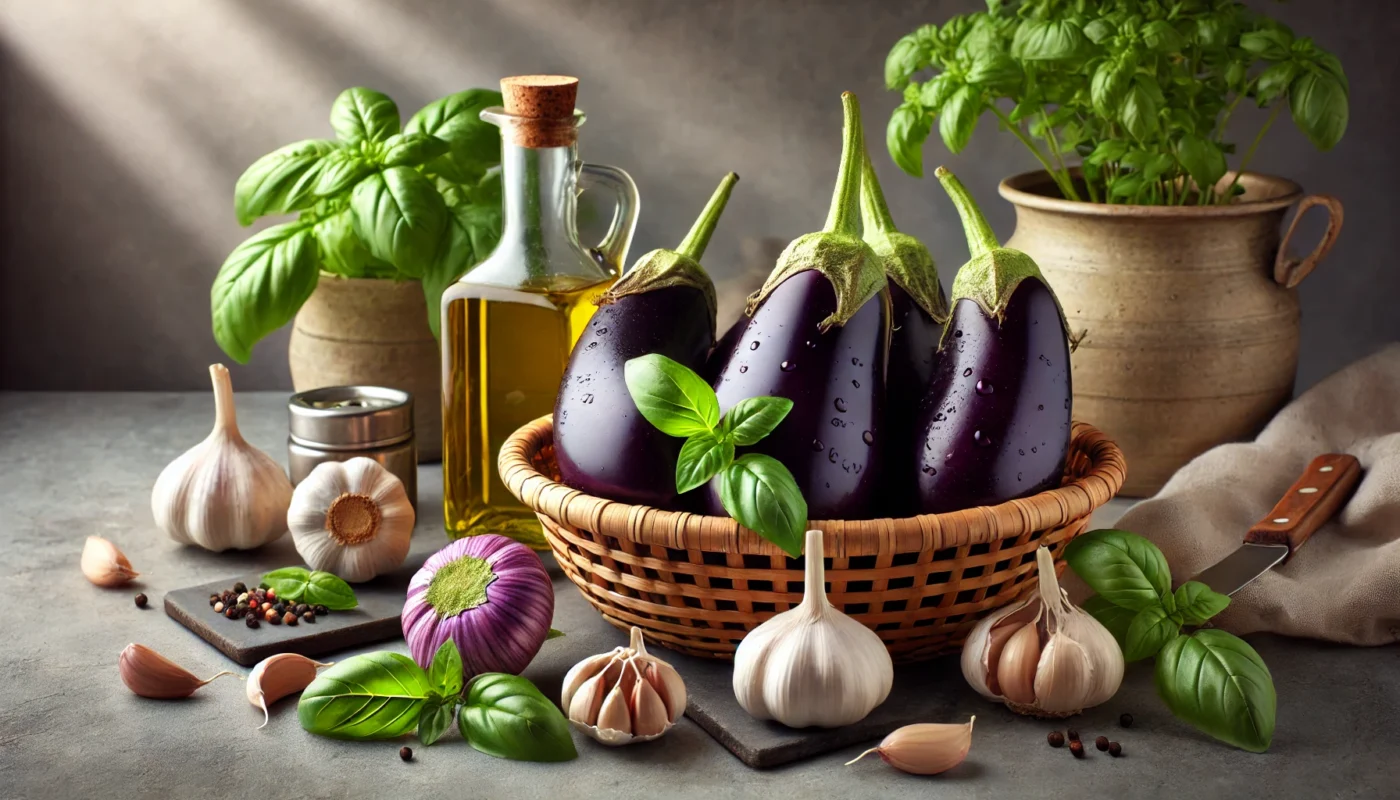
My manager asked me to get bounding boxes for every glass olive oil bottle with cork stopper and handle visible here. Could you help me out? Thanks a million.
[442,76,637,549]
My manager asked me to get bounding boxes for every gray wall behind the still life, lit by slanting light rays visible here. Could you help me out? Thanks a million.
[0,0,1400,389]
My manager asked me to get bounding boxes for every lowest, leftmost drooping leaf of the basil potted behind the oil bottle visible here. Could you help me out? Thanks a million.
[209,221,319,364]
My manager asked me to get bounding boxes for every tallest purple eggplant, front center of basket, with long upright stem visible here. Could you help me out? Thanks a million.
[707,92,890,518]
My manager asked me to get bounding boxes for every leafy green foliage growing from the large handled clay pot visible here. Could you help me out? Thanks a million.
[885,0,1348,205]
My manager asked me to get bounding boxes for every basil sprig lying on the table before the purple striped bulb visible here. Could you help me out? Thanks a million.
[297,639,578,761]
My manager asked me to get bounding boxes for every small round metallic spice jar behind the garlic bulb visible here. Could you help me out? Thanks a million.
[287,387,419,510]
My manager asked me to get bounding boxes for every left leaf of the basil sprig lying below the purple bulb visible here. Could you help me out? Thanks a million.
[297,651,433,738]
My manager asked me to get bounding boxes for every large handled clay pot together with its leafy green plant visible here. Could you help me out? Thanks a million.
[885,0,1348,496]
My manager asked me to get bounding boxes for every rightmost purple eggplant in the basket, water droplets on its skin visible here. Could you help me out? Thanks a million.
[916,167,1071,513]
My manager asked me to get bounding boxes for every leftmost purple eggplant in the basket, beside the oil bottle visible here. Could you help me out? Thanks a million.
[554,172,739,509]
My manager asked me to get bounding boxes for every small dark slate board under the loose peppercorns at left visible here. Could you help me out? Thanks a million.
[165,570,413,667]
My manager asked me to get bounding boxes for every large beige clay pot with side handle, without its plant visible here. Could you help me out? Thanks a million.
[1000,172,1341,497]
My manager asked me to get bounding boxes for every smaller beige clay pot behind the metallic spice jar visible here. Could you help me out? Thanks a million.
[287,272,442,462]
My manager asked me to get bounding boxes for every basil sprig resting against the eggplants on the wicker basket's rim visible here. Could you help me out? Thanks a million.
[623,353,806,558]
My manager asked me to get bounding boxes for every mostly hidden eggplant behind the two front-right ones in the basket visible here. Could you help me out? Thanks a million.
[861,156,948,516]
